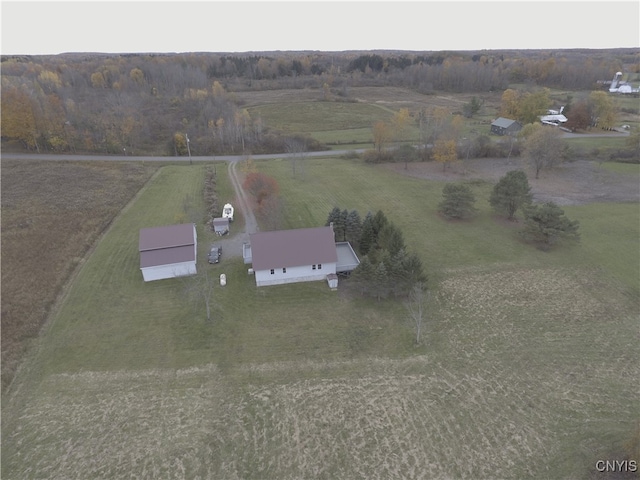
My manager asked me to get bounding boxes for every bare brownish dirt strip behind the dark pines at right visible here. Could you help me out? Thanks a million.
[387,158,640,205]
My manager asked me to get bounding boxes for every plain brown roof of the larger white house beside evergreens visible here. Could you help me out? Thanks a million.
[250,227,338,270]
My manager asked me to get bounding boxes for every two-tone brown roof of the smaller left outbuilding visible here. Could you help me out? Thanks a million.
[138,223,196,268]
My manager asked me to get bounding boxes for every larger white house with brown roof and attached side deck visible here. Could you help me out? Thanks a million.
[243,226,359,287]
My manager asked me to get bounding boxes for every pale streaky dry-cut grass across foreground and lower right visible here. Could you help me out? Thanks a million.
[3,270,640,479]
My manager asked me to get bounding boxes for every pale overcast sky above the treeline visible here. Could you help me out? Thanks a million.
[0,0,640,55]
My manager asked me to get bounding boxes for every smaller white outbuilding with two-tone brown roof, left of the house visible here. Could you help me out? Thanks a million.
[138,223,198,282]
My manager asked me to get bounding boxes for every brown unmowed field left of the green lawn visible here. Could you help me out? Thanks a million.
[2,160,157,391]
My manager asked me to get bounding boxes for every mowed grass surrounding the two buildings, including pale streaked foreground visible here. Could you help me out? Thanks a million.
[2,158,640,479]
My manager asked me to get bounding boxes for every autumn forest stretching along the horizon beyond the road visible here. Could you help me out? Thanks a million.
[1,49,640,155]
